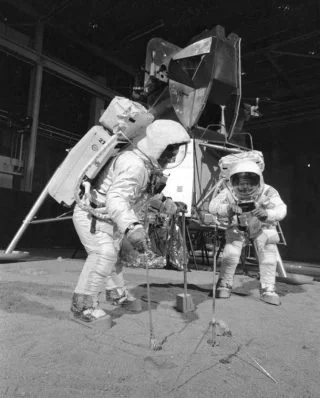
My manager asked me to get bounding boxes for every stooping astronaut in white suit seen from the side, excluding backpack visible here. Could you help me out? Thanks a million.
[71,120,190,322]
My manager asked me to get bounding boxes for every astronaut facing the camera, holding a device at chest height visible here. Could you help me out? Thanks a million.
[209,155,287,305]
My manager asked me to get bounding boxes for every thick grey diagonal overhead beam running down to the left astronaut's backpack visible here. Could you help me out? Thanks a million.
[0,34,119,98]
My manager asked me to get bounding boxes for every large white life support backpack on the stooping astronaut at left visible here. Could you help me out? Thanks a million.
[47,97,154,208]
